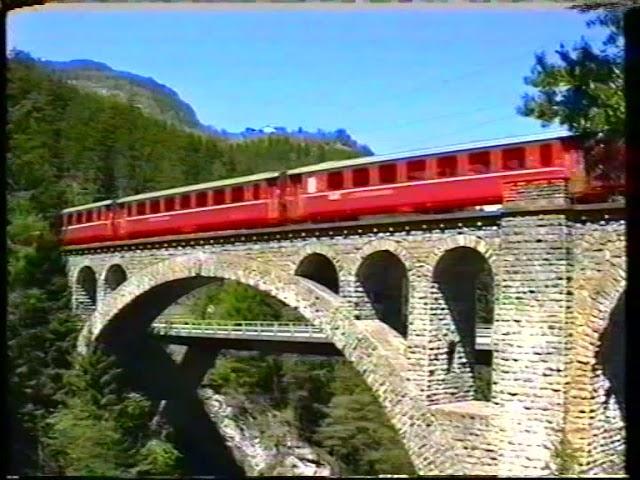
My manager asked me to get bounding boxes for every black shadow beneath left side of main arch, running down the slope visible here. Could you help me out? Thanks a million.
[97,277,245,478]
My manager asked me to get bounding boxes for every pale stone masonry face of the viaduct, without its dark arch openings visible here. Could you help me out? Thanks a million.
[68,188,624,475]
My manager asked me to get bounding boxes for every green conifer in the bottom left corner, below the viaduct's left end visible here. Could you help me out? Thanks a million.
[45,351,180,476]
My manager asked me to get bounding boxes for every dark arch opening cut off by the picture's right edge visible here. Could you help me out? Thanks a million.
[596,292,626,421]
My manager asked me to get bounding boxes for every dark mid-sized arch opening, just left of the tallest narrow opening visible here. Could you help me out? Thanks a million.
[356,250,409,338]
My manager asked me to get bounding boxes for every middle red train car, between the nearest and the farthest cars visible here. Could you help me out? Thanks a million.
[114,172,284,240]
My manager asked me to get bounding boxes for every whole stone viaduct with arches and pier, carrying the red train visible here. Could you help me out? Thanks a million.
[66,182,626,476]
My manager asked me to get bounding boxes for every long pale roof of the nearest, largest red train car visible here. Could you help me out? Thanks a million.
[287,131,574,175]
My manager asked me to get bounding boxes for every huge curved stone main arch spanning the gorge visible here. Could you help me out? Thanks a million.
[78,253,459,473]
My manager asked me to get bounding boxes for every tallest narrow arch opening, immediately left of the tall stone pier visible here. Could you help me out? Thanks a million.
[428,246,495,400]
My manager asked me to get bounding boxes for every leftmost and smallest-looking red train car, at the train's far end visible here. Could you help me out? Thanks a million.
[61,200,113,245]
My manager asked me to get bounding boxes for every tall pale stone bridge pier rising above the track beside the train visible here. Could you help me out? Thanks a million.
[493,181,571,476]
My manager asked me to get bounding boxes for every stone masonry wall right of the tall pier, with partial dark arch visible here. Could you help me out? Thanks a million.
[566,219,626,474]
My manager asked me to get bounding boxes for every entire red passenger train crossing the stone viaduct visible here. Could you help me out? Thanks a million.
[62,135,610,246]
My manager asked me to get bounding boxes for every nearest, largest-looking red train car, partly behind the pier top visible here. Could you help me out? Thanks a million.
[285,134,583,221]
